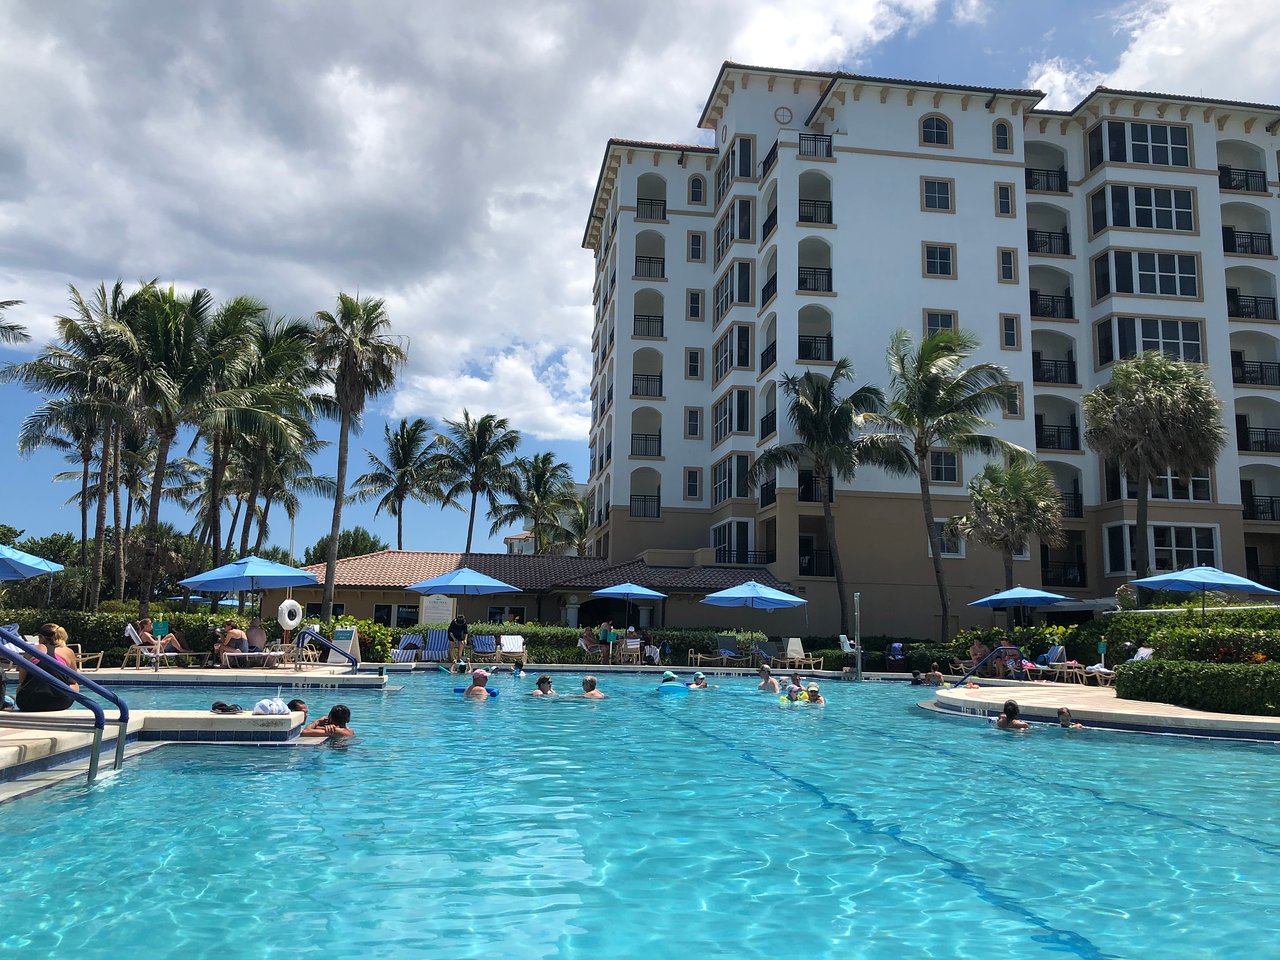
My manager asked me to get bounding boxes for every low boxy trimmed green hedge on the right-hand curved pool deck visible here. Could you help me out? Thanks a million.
[1116,659,1280,717]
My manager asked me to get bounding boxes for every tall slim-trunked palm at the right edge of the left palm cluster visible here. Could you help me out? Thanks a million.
[314,293,407,623]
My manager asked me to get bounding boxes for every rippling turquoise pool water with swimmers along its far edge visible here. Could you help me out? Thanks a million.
[0,675,1280,960]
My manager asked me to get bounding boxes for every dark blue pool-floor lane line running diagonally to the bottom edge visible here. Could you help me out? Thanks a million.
[649,705,1119,960]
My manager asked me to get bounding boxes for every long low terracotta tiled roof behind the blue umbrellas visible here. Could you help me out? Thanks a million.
[295,550,790,593]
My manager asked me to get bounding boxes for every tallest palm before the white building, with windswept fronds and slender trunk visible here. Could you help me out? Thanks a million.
[879,329,1027,643]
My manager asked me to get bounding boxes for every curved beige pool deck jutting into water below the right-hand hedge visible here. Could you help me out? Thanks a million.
[920,680,1280,742]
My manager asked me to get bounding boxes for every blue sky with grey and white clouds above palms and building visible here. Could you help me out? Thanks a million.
[0,0,1280,553]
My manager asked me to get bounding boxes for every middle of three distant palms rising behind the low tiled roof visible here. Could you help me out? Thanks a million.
[434,410,520,553]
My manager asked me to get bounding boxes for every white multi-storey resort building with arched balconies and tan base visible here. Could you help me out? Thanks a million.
[584,63,1280,636]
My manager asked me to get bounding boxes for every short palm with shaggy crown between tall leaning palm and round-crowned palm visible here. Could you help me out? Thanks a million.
[947,457,1064,623]
